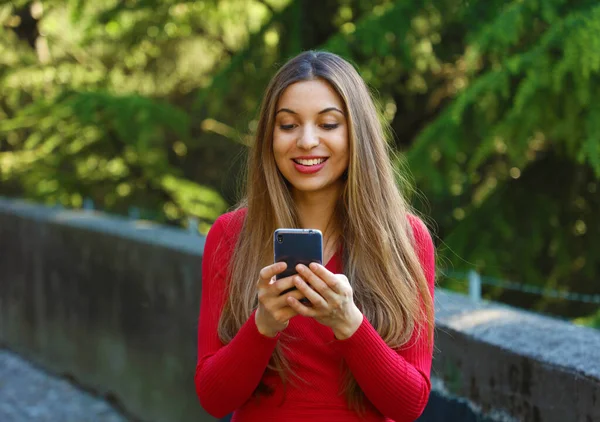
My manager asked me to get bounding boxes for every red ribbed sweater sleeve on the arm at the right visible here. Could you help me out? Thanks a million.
[336,216,435,422]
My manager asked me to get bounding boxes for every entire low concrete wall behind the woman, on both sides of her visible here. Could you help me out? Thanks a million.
[0,199,600,422]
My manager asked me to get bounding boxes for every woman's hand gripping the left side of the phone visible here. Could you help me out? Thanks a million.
[254,262,304,337]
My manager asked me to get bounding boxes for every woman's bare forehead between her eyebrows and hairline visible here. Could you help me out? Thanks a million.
[277,79,345,112]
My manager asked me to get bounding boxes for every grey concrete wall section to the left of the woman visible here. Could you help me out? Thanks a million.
[0,200,214,422]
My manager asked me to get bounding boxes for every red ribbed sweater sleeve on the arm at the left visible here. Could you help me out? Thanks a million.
[194,214,278,418]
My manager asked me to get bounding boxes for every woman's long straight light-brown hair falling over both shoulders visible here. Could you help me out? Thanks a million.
[219,51,433,411]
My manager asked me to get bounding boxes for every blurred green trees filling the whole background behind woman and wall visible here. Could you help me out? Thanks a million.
[0,0,600,326]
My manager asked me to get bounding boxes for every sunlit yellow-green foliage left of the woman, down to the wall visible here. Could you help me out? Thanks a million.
[0,0,285,227]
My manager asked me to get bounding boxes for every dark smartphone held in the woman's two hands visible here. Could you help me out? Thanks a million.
[273,229,323,279]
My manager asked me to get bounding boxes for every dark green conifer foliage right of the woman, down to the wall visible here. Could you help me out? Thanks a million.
[408,0,600,315]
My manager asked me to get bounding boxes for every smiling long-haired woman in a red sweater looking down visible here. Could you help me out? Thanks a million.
[195,52,434,422]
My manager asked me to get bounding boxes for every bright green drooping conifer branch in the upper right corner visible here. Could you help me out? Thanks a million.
[411,3,600,204]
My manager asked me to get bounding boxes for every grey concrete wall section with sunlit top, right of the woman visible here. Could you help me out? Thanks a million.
[434,290,600,422]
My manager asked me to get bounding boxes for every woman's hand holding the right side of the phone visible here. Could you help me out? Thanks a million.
[288,263,363,340]
